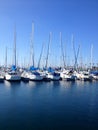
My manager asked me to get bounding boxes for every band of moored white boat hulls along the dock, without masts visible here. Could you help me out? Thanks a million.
[0,66,98,82]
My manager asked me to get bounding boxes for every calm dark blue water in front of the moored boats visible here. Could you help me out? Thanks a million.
[0,81,98,130]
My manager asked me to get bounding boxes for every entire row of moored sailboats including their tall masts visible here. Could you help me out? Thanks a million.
[0,22,98,82]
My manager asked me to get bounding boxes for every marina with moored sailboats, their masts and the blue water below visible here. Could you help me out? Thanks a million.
[0,14,98,130]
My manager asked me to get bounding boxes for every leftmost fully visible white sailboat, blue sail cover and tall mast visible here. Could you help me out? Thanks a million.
[5,25,21,81]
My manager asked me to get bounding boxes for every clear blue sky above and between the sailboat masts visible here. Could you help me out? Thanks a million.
[0,0,98,65]
